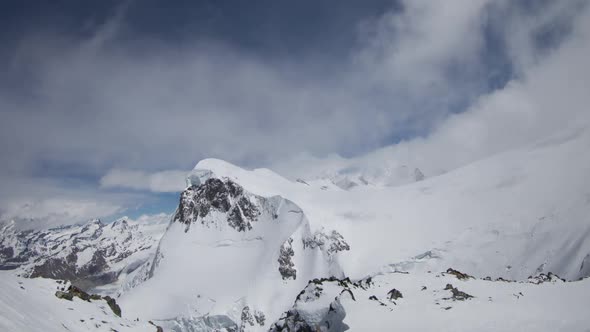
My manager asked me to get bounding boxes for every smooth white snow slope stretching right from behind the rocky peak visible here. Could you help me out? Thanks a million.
[191,128,590,279]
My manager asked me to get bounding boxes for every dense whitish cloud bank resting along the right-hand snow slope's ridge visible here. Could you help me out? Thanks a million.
[402,2,590,169]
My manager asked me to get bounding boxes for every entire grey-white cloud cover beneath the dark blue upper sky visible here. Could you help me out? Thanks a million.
[0,0,590,228]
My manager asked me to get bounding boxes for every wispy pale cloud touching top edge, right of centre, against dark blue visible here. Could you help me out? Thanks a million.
[360,0,491,89]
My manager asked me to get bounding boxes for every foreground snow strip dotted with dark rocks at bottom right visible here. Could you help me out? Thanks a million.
[272,273,590,331]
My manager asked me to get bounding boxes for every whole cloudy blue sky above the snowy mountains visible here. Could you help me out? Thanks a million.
[0,0,588,227]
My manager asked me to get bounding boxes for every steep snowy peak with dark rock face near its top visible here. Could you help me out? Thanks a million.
[120,176,347,329]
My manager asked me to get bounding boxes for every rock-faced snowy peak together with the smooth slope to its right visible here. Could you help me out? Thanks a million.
[120,124,590,330]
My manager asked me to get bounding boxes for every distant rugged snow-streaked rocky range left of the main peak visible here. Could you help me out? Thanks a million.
[0,218,167,288]
